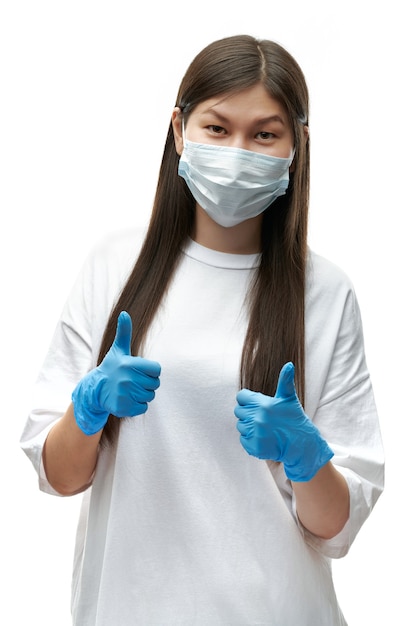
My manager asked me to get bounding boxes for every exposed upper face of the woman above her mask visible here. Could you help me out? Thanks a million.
[172,83,294,158]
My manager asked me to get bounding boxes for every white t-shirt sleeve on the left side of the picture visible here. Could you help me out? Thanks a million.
[20,228,138,494]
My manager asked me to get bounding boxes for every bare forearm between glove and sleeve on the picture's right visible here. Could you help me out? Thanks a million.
[292,461,350,539]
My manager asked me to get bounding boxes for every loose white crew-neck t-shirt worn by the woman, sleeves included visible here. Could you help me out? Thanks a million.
[21,231,383,626]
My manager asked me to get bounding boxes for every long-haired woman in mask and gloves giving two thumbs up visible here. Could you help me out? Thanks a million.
[22,36,383,626]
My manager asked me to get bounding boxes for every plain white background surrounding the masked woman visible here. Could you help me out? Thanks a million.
[0,0,417,626]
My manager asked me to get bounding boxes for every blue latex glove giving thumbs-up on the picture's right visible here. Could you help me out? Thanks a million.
[235,363,333,482]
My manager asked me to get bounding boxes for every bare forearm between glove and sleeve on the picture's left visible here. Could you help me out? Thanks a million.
[43,404,102,496]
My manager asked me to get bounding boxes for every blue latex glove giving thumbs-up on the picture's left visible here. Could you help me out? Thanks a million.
[72,311,161,435]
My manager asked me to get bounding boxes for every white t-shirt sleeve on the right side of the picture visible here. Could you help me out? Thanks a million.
[293,256,384,558]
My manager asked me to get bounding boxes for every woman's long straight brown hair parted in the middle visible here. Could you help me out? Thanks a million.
[98,35,310,443]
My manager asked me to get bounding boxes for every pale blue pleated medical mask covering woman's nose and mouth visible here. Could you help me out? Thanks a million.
[178,127,294,227]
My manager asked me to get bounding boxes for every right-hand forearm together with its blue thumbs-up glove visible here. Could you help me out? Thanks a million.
[235,363,350,539]
